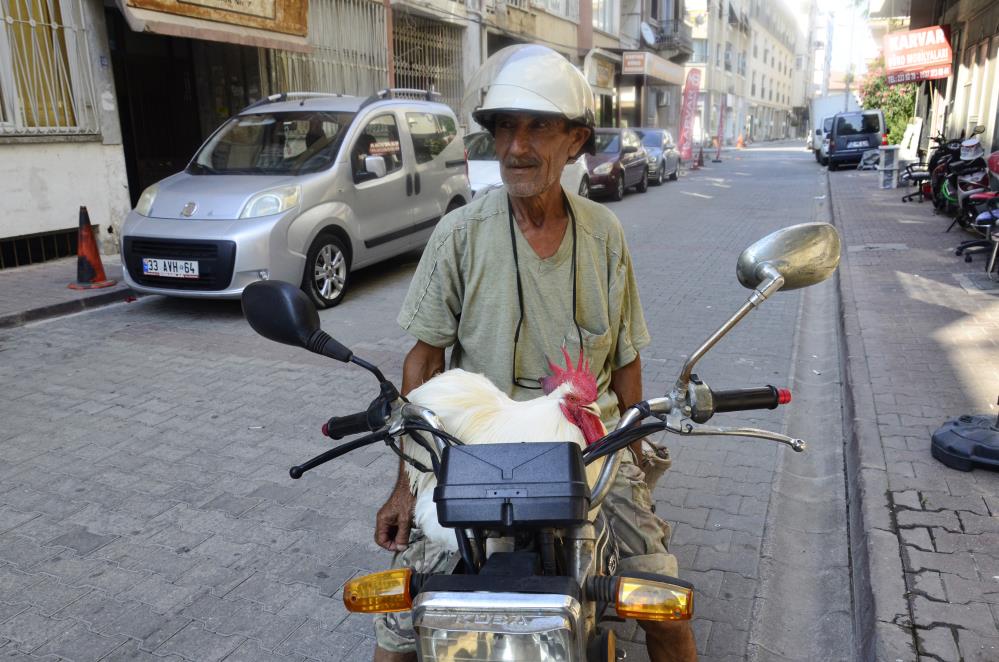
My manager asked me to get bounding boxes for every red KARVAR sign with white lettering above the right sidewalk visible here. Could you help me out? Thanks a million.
[884,25,953,85]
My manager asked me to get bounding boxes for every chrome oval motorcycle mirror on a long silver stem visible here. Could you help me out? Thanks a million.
[735,223,840,290]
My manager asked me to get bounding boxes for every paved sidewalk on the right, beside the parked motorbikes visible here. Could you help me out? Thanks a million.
[829,172,999,662]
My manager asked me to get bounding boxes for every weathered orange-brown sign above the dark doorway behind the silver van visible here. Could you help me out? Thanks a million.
[125,0,309,36]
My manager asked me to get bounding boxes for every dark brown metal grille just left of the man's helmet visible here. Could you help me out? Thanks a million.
[392,11,462,112]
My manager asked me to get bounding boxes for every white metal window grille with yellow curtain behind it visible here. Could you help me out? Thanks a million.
[0,0,99,135]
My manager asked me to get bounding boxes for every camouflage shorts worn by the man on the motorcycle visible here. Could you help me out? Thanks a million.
[375,452,678,653]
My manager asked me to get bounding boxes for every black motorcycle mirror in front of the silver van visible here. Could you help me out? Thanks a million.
[243,280,353,363]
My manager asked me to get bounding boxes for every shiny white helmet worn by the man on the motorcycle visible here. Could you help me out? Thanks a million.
[464,44,596,154]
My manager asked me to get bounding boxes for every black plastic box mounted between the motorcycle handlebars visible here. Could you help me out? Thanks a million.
[434,441,590,529]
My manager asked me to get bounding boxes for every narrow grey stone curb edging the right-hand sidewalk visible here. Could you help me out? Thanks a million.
[825,170,917,662]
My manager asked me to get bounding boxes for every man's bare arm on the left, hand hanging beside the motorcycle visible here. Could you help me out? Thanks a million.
[375,340,444,552]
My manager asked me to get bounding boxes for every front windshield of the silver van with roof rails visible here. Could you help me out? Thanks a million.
[187,110,354,175]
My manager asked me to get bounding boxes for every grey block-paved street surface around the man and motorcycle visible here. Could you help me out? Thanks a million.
[0,146,844,662]
